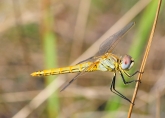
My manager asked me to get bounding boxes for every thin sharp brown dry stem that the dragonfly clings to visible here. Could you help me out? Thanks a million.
[128,0,162,118]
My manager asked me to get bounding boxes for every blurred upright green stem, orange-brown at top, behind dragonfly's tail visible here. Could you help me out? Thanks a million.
[42,0,59,118]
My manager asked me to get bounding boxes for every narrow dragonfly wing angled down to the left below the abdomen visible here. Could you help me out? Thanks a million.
[61,63,96,91]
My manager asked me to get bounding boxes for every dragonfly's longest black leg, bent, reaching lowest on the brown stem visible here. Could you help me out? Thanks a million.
[110,73,134,104]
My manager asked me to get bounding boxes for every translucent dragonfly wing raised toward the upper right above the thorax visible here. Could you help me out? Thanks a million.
[96,22,135,56]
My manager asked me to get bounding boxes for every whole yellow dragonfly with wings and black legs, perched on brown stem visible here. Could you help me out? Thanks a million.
[31,22,142,104]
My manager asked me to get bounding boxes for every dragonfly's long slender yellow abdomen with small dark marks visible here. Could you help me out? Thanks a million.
[31,62,97,76]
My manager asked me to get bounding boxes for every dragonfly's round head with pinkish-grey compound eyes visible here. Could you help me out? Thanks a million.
[120,55,134,70]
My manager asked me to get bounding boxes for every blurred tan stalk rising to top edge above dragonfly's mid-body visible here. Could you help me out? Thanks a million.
[69,0,91,63]
